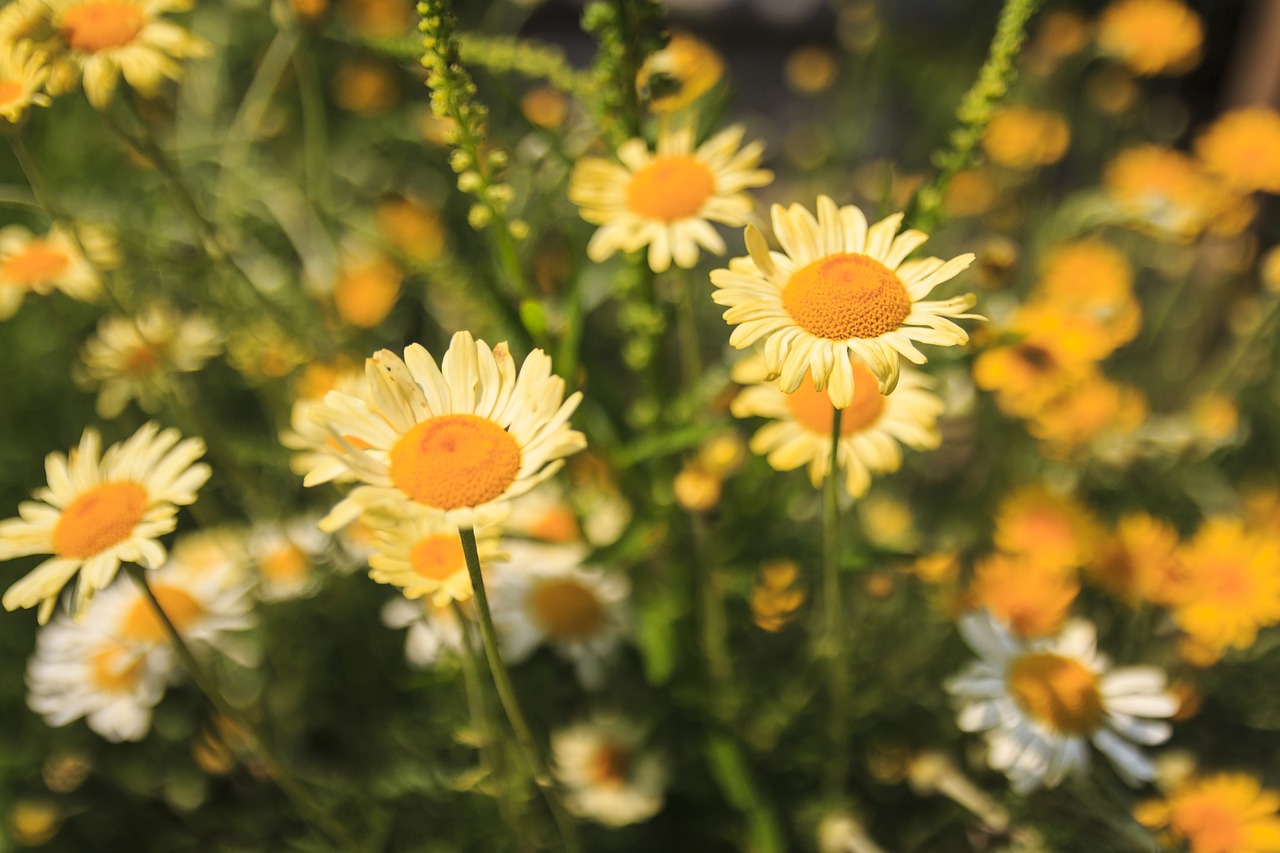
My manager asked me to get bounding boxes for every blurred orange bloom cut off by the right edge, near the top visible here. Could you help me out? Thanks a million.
[1196,106,1280,193]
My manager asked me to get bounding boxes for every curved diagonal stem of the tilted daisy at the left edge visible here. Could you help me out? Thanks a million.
[124,564,361,850]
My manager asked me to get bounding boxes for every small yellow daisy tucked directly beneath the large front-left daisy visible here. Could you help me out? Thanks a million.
[369,516,500,607]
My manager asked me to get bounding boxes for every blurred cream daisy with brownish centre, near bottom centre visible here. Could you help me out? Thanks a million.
[552,715,667,826]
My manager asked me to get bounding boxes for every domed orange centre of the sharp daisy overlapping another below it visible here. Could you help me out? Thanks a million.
[782,254,911,341]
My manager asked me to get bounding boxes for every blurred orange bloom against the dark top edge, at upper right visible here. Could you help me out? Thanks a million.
[1098,0,1204,76]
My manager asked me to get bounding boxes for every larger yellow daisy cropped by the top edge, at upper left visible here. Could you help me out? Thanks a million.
[49,0,209,109]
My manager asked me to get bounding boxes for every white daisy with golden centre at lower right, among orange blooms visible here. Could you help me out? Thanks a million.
[946,612,1178,794]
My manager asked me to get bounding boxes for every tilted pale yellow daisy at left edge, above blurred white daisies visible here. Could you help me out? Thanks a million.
[0,424,210,624]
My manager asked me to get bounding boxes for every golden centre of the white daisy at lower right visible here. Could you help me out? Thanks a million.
[1005,652,1103,735]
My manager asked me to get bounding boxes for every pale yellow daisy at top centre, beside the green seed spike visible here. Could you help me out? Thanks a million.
[568,126,773,273]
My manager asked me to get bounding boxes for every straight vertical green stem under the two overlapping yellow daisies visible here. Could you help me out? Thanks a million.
[822,409,849,798]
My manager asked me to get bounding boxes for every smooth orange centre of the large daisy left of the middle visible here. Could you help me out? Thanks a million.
[390,415,520,510]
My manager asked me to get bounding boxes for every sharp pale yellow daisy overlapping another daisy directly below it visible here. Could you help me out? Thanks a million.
[712,196,974,409]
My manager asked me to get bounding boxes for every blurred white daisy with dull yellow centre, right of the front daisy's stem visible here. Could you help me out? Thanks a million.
[489,542,631,689]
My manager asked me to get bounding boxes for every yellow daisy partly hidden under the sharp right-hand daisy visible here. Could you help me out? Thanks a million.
[730,353,943,497]
